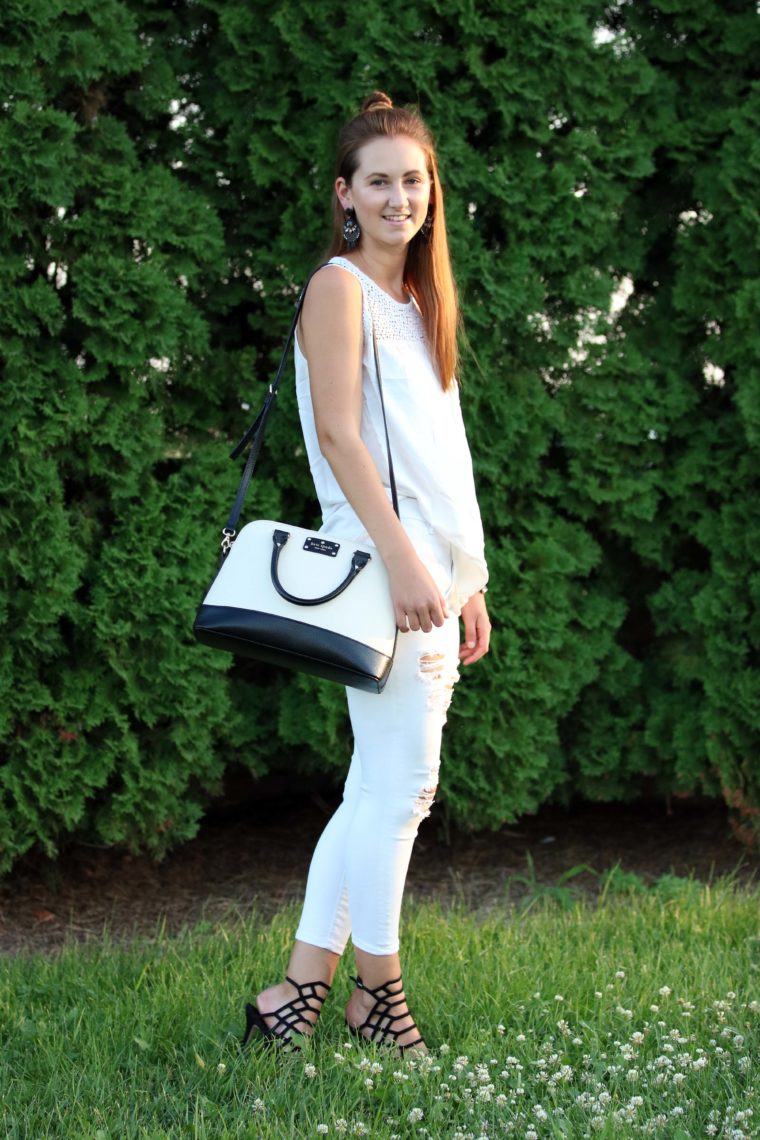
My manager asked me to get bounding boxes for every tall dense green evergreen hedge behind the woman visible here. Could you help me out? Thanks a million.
[0,0,760,870]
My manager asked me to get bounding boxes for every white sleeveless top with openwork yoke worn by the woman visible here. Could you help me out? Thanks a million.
[295,258,488,613]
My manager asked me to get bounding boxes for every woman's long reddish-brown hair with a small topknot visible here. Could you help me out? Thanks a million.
[328,91,460,390]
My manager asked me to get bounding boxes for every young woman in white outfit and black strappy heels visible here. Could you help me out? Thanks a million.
[243,92,491,1052]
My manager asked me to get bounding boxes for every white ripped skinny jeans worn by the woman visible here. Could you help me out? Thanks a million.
[296,515,459,954]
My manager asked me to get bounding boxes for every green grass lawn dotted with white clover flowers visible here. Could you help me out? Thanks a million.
[0,876,760,1140]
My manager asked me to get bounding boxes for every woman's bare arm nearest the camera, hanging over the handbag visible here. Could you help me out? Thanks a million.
[300,267,448,633]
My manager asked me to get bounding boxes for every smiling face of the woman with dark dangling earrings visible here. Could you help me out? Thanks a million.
[335,136,431,253]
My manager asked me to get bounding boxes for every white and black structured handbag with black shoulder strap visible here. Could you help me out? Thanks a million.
[193,266,399,693]
